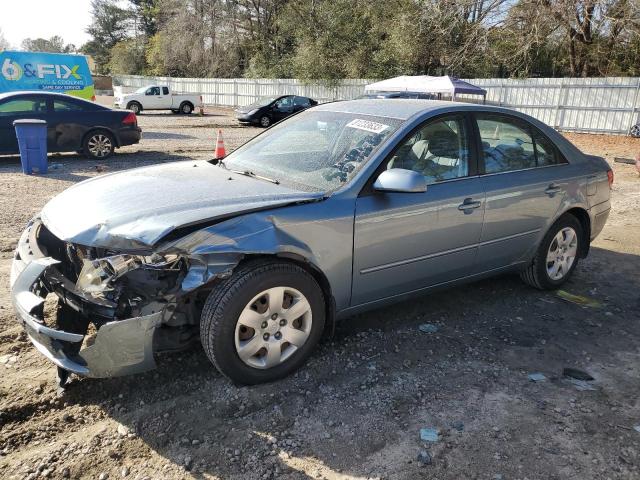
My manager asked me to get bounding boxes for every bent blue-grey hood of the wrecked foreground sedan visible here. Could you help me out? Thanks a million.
[41,161,323,250]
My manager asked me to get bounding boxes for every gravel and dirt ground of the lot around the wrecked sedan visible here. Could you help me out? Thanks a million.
[0,107,640,480]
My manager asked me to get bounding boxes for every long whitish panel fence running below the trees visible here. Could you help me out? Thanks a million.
[113,75,640,134]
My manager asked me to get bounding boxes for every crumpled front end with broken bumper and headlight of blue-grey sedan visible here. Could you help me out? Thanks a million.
[11,219,182,377]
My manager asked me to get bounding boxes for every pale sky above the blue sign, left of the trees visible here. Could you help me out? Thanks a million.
[0,0,91,48]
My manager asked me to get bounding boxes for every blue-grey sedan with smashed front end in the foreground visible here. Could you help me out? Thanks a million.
[11,99,613,384]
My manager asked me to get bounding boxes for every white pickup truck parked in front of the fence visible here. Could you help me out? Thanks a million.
[113,85,202,115]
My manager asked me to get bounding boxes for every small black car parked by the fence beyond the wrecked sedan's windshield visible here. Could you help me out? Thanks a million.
[236,95,318,128]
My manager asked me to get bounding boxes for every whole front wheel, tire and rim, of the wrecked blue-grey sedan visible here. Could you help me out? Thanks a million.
[200,261,325,385]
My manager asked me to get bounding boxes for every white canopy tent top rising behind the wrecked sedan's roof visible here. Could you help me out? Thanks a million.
[364,75,487,99]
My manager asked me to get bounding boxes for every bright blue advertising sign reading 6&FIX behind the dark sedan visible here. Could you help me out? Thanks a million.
[0,51,95,100]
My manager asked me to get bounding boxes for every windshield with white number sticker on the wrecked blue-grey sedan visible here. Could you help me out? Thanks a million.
[224,111,401,192]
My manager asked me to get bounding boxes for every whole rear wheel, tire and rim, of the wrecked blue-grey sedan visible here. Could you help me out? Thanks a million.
[520,213,584,290]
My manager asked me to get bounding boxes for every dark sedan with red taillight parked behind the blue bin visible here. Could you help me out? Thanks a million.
[0,92,141,159]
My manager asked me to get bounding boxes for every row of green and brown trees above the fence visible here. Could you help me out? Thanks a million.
[13,0,640,81]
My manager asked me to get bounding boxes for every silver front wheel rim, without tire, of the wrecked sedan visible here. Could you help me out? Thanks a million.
[234,287,312,369]
